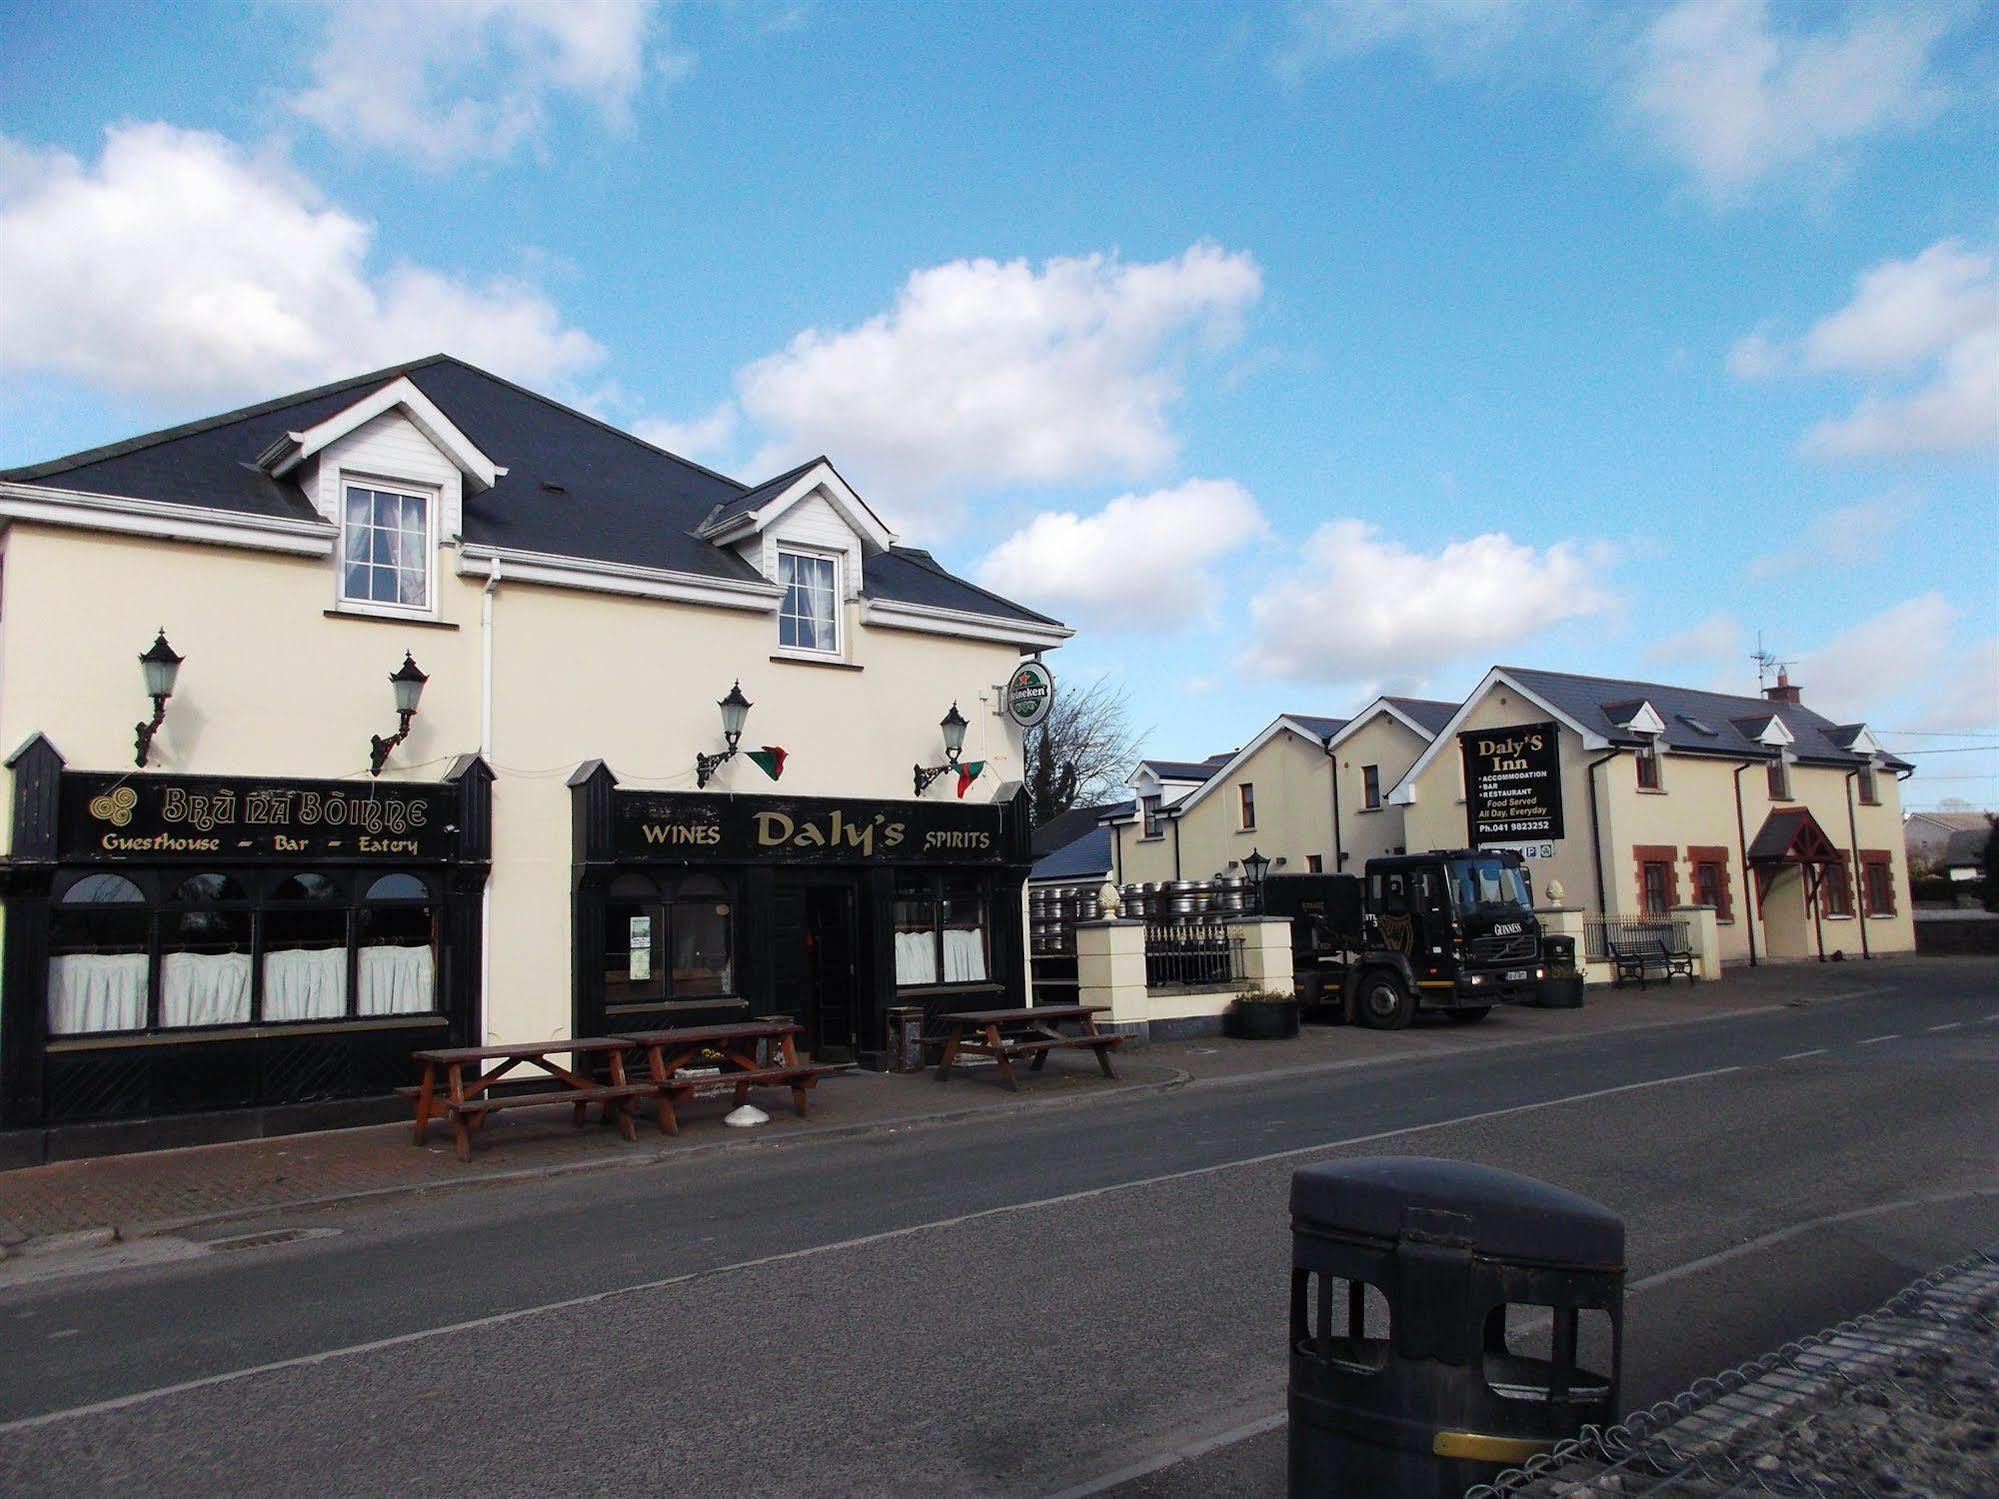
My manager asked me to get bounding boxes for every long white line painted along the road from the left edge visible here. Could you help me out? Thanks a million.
[0,1065,1741,1437]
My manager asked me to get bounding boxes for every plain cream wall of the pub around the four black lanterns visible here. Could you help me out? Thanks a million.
[0,524,1021,1039]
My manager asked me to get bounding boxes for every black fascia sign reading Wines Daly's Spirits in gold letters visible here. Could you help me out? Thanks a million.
[612,791,1005,863]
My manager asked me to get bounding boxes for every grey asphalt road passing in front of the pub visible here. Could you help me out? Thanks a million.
[0,961,1999,1495]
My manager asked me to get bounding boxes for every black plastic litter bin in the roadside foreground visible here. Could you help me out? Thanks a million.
[1289,1155,1625,1499]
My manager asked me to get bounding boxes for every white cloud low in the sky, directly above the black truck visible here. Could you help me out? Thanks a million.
[1241,520,1613,682]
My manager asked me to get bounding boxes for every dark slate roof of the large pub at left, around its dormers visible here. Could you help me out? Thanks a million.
[0,354,1055,624]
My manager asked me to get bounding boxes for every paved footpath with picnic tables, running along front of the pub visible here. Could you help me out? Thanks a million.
[0,959,1923,1247]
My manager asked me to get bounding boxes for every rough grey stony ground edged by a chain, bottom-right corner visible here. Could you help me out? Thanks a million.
[1465,1251,1999,1499]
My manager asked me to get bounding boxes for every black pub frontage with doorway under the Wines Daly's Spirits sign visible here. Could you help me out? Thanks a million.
[570,761,1033,1067]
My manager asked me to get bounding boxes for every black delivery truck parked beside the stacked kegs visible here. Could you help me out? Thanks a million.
[1263,849,1543,1029]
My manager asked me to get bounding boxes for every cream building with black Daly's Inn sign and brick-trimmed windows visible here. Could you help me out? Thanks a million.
[1389,668,1915,961]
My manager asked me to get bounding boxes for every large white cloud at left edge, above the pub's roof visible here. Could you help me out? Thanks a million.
[0,124,604,404]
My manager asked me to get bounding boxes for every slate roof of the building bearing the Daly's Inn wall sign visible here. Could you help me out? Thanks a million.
[1499,666,1911,769]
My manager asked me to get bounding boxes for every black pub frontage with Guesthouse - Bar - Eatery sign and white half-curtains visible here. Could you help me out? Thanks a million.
[0,736,492,1163]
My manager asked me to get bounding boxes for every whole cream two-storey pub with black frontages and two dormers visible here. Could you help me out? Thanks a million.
[0,356,1069,1153]
